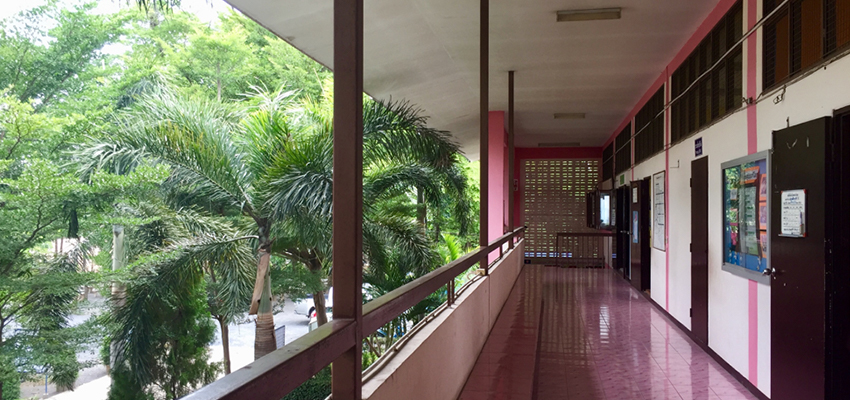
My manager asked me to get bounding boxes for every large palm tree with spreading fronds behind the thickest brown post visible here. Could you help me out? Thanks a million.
[84,86,465,359]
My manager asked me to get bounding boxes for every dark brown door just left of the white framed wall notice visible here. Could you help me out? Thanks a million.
[629,178,651,291]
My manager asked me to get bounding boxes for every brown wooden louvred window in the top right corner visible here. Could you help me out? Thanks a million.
[762,0,850,89]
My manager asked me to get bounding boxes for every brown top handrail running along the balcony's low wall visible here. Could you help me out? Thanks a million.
[184,227,526,400]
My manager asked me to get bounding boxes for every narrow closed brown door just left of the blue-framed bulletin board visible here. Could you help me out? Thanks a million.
[691,157,708,344]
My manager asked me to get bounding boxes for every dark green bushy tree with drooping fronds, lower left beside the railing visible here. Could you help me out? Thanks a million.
[94,200,250,399]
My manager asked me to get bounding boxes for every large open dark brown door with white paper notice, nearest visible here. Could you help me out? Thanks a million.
[770,118,828,400]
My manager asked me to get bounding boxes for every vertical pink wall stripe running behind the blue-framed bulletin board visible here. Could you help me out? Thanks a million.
[746,0,759,386]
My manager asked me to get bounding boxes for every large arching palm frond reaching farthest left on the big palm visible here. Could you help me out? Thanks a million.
[82,91,254,213]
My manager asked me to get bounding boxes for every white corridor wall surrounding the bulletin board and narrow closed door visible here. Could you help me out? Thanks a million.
[616,28,850,396]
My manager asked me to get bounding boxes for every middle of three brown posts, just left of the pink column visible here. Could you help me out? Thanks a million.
[478,0,490,274]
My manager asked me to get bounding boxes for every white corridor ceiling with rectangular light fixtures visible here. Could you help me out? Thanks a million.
[227,0,719,159]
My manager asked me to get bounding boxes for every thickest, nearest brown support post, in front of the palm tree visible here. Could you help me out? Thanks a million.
[332,0,363,400]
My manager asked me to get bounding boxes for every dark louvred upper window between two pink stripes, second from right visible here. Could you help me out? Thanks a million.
[670,1,744,142]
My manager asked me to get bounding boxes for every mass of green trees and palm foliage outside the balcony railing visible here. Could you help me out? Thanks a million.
[0,0,477,399]
